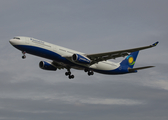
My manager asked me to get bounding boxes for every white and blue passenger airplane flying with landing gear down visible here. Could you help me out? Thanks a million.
[9,36,159,79]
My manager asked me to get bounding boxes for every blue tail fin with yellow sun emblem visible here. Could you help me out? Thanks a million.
[120,51,139,68]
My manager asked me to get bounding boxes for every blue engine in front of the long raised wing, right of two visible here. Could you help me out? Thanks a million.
[72,54,91,64]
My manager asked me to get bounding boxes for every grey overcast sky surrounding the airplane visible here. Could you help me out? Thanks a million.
[0,0,168,120]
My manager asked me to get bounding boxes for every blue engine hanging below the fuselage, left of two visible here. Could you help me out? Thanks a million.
[39,61,57,71]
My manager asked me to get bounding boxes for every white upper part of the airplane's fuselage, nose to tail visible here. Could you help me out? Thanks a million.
[10,36,120,71]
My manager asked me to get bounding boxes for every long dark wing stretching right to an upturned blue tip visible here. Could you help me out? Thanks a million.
[85,42,159,65]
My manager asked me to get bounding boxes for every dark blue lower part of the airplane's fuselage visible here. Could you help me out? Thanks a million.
[14,45,136,75]
